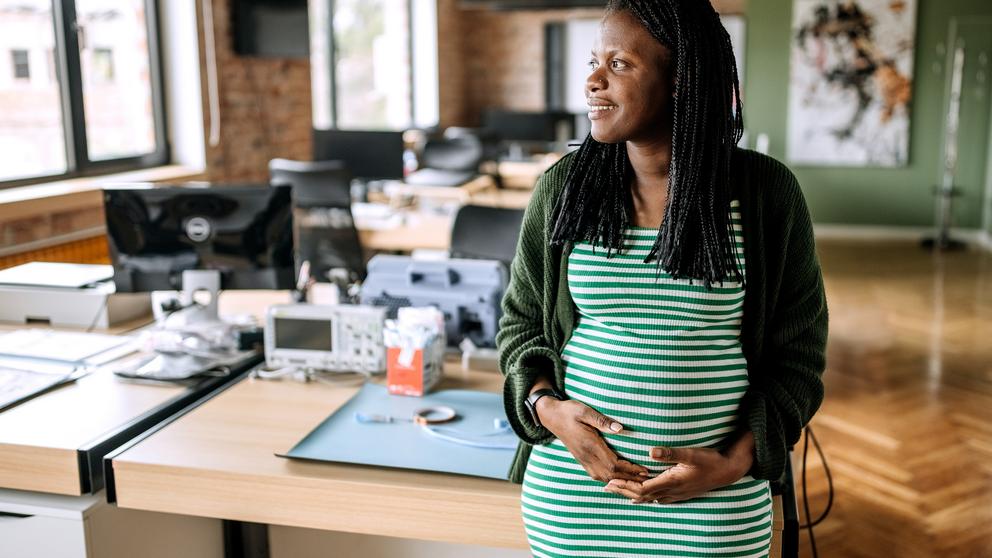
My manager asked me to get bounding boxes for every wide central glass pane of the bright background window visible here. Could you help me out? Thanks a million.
[334,0,412,129]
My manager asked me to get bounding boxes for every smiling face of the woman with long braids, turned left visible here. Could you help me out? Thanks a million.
[586,11,672,143]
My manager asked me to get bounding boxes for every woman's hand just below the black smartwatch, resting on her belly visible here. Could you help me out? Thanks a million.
[537,397,649,483]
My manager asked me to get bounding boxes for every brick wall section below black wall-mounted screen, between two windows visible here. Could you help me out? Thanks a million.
[198,0,312,182]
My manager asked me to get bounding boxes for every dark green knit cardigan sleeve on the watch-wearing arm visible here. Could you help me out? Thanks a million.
[496,163,564,445]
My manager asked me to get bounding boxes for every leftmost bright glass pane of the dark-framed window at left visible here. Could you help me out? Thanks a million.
[0,0,66,181]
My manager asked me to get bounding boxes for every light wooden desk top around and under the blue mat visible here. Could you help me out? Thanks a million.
[114,365,526,548]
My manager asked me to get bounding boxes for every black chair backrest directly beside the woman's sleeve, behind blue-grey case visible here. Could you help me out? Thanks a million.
[451,205,524,269]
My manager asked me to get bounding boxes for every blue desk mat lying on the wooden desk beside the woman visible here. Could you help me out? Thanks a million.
[277,384,516,479]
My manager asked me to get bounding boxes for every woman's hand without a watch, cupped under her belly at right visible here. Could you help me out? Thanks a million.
[606,432,754,504]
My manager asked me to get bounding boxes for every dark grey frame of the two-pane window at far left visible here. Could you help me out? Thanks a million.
[0,0,171,190]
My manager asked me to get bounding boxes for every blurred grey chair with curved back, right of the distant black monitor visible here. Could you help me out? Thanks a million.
[406,134,483,186]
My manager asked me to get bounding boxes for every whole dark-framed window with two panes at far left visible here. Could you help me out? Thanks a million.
[0,0,168,188]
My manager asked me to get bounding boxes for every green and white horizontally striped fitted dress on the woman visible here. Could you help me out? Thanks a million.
[521,200,772,558]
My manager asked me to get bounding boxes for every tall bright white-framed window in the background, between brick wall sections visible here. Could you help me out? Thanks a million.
[310,0,438,130]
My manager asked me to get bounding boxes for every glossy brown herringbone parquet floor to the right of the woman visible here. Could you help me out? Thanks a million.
[794,241,992,558]
